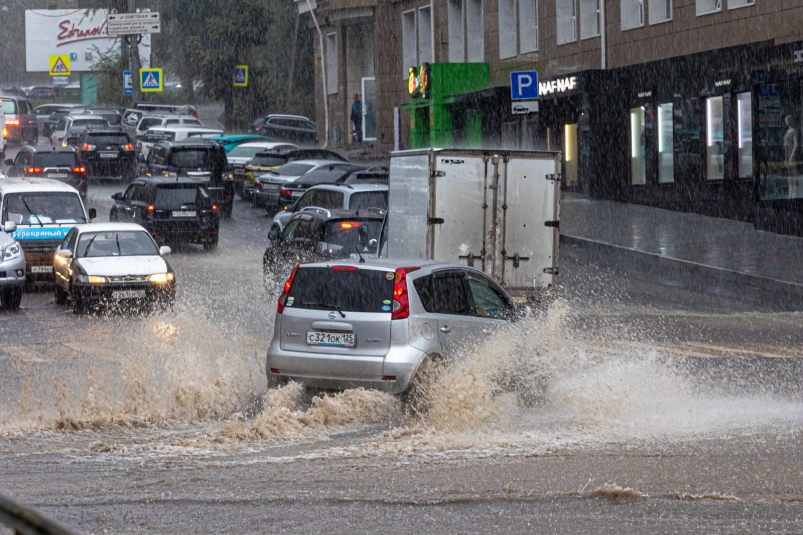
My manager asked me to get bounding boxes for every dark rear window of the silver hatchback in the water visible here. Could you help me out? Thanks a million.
[286,266,394,314]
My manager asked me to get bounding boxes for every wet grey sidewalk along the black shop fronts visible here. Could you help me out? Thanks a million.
[560,193,803,304]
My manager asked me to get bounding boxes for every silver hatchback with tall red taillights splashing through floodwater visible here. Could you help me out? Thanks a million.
[266,259,522,394]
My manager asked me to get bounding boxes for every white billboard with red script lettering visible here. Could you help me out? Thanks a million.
[25,9,151,72]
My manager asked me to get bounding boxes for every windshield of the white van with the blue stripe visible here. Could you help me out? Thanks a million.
[3,192,86,225]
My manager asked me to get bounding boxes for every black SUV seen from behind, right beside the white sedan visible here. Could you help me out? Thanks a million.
[109,176,219,250]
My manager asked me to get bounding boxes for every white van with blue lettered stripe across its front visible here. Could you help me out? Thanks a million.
[0,177,96,282]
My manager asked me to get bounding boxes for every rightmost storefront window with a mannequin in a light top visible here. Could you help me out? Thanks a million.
[756,80,803,200]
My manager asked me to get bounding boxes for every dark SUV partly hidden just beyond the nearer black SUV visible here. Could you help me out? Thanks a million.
[140,139,234,217]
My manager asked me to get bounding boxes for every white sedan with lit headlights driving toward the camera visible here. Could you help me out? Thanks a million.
[53,223,176,313]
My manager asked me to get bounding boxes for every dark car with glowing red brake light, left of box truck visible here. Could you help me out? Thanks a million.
[262,208,384,280]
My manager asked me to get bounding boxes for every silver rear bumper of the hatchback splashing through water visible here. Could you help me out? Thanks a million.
[265,338,425,394]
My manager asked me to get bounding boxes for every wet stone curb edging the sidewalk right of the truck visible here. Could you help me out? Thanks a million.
[560,234,803,310]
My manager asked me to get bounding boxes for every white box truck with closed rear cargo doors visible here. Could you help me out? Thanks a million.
[381,149,561,301]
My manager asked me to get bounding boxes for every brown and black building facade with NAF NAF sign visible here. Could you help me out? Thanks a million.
[298,0,803,235]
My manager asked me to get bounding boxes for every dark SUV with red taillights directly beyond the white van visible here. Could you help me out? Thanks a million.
[5,145,87,201]
